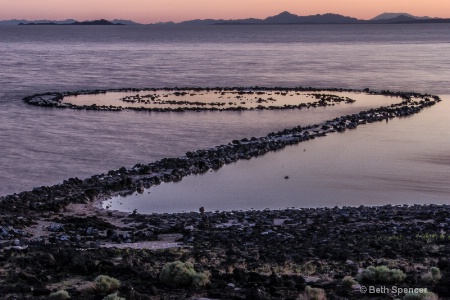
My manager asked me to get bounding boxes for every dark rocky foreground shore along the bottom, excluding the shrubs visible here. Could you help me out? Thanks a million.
[0,204,450,299]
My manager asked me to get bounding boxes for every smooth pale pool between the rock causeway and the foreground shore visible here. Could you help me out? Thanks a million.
[102,95,450,213]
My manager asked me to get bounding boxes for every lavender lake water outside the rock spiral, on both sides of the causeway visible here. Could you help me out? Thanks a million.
[0,24,450,211]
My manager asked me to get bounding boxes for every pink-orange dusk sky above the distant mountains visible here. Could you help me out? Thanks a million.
[0,0,450,23]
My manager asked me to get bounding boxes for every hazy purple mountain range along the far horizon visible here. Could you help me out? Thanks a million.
[0,11,450,26]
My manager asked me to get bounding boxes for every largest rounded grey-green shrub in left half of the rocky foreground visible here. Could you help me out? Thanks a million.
[159,261,209,286]
